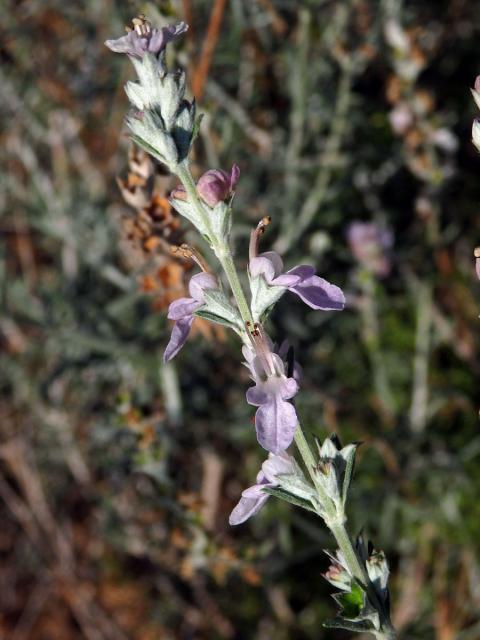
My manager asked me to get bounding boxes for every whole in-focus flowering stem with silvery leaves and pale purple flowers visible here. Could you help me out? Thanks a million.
[106,16,396,638]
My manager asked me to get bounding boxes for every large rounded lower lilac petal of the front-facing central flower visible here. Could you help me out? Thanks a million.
[255,396,298,453]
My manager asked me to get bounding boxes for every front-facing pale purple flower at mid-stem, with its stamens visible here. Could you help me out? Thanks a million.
[242,325,299,454]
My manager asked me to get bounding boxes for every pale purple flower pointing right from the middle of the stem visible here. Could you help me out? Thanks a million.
[249,251,345,311]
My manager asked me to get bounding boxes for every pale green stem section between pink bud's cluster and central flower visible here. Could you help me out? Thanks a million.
[176,164,253,324]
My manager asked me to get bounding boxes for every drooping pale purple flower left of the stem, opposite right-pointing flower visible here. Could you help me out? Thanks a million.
[163,273,218,362]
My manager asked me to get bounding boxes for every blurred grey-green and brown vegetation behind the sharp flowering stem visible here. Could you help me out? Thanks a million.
[0,0,480,640]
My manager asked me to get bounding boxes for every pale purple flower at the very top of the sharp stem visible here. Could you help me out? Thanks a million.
[105,18,188,59]
